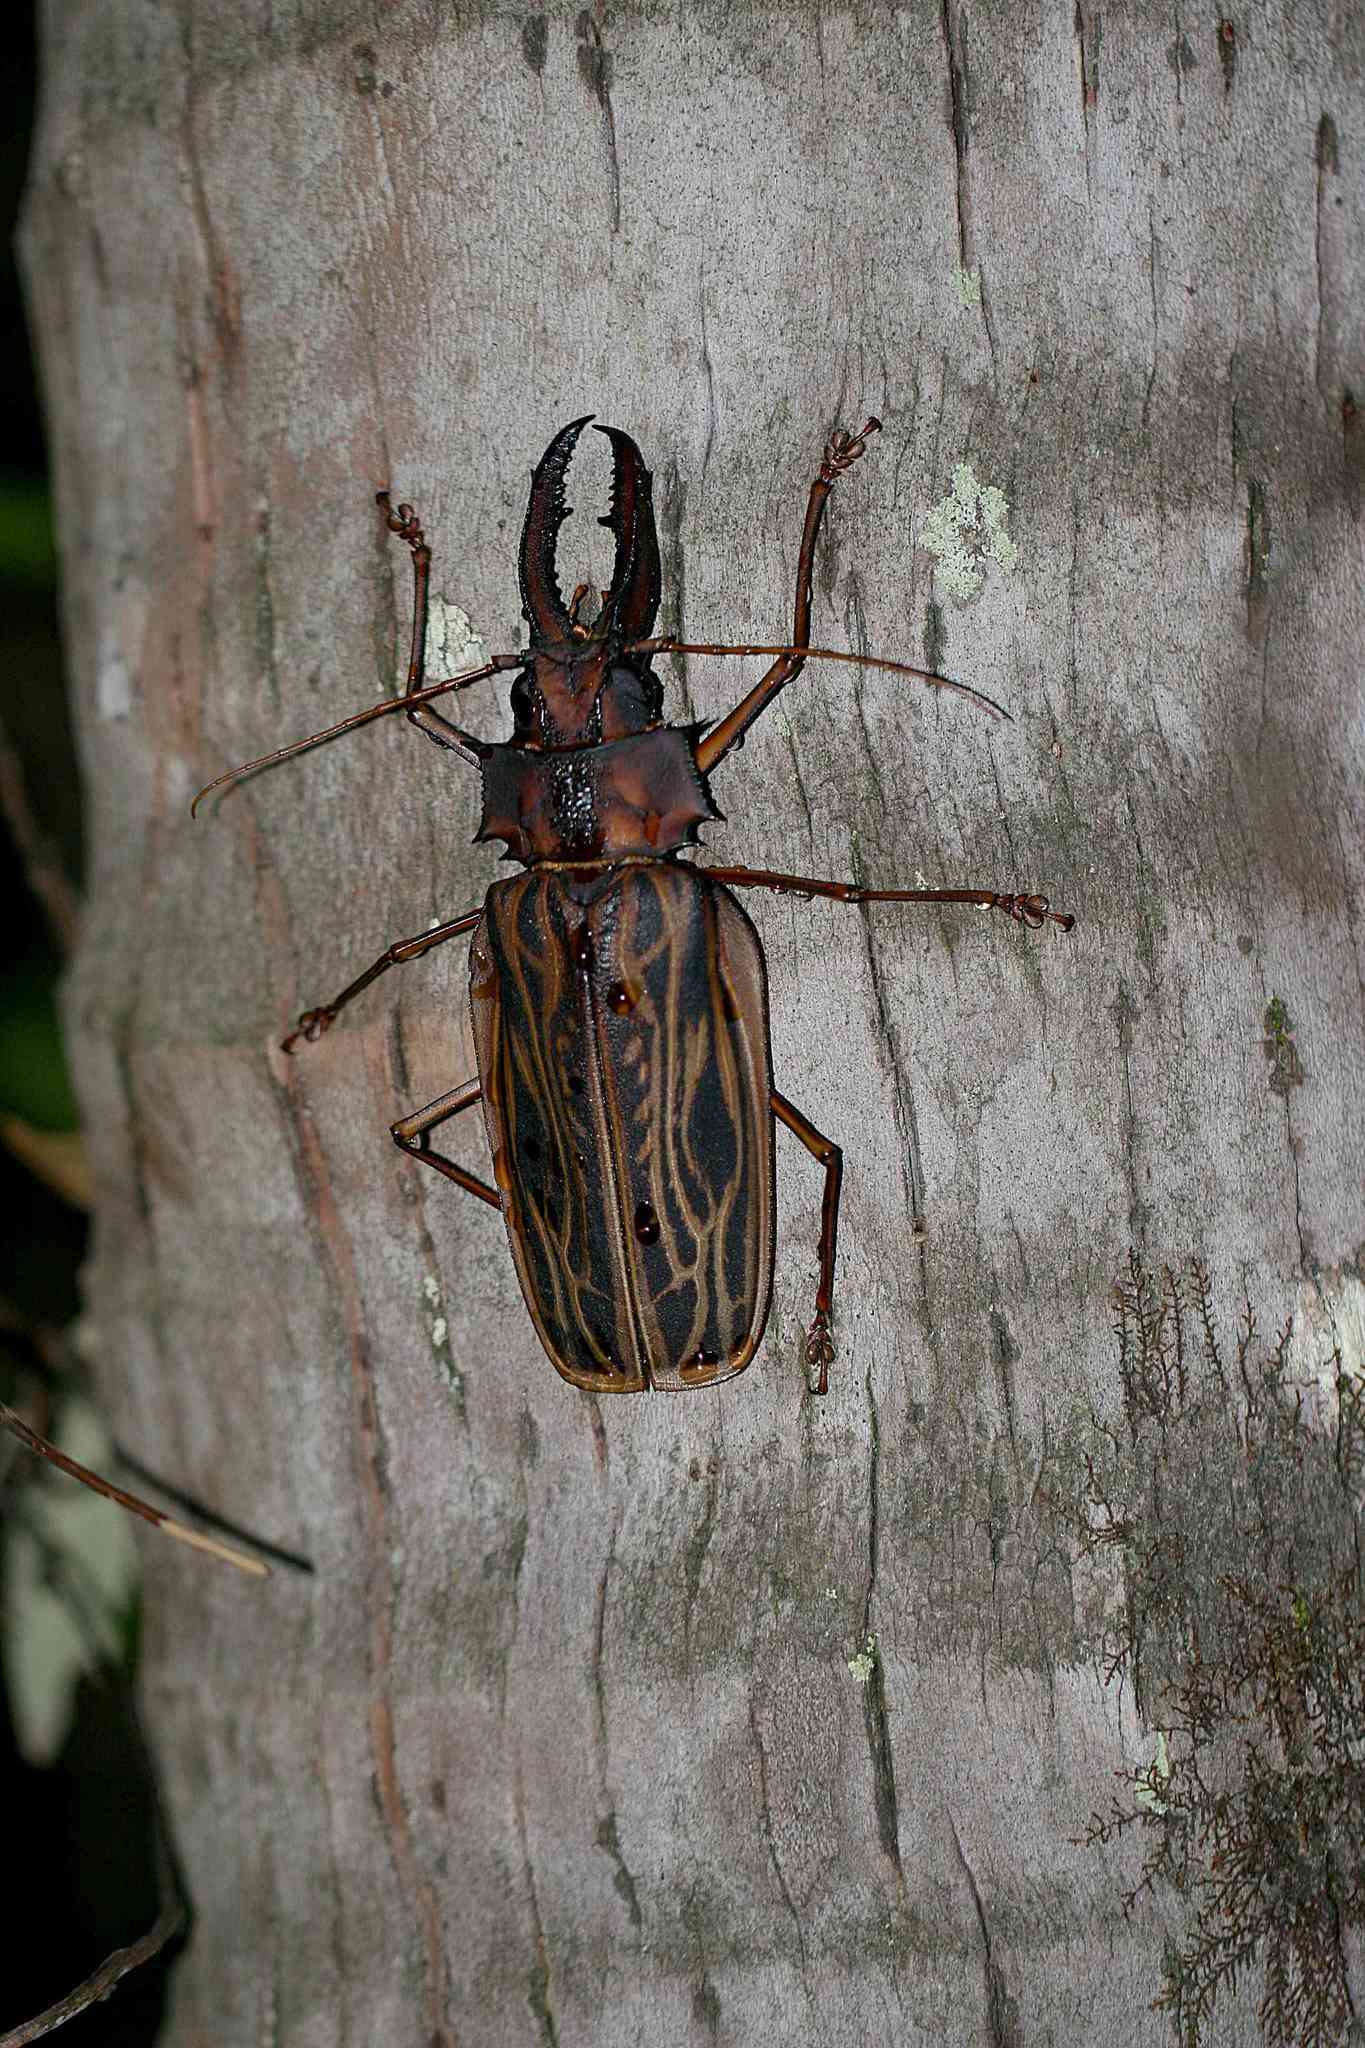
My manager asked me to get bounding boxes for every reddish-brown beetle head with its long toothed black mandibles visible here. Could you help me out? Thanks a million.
[512,414,663,748]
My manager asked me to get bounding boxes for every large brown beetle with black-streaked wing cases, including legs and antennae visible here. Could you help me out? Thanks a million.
[194,414,1072,1395]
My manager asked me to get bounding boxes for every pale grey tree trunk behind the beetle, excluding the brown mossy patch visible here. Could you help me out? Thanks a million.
[25,0,1365,2048]
